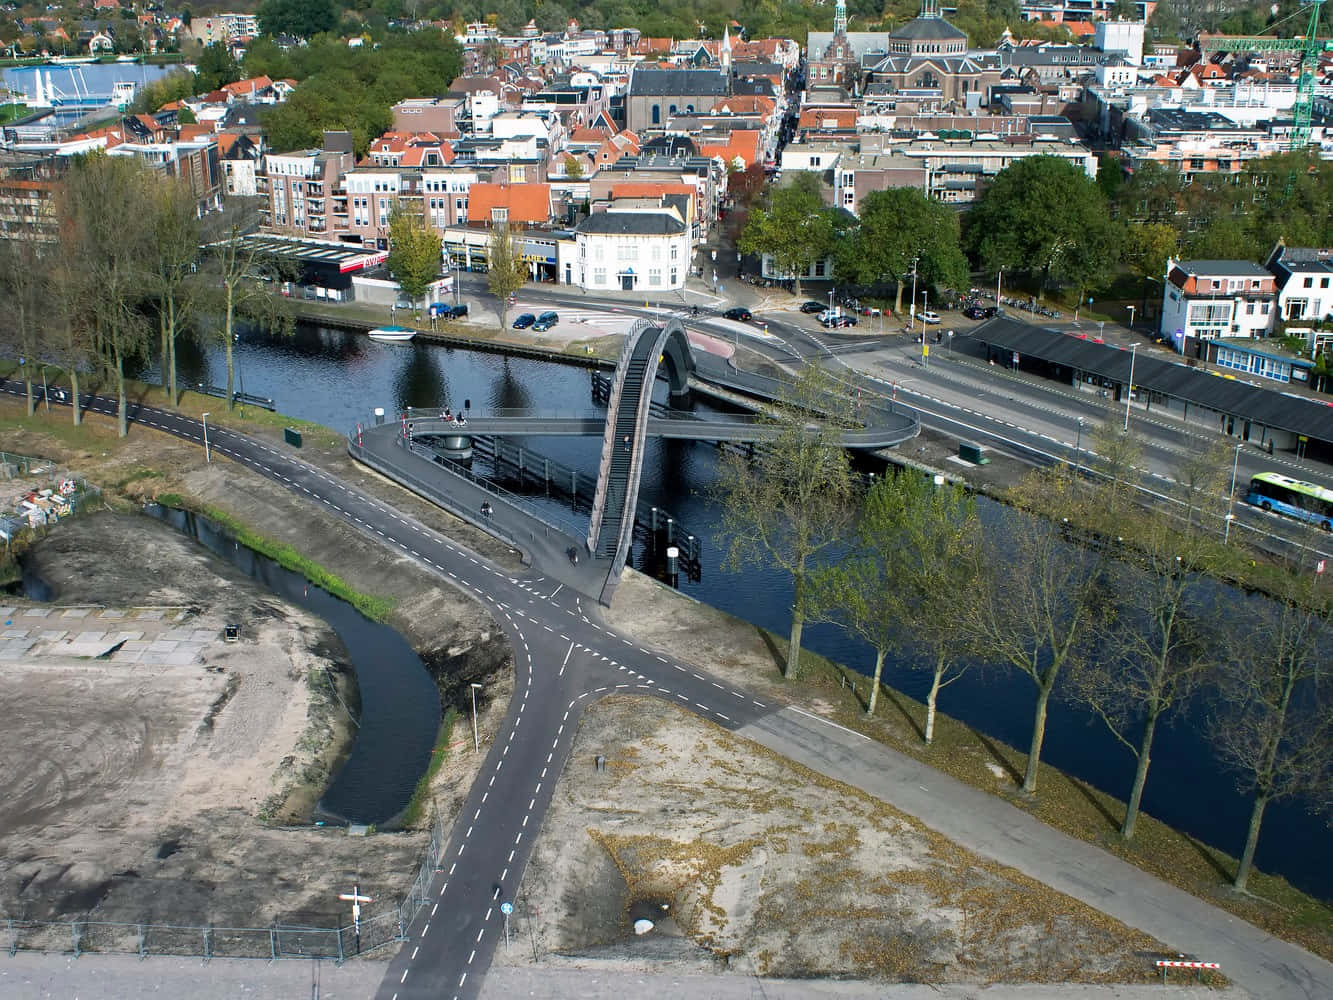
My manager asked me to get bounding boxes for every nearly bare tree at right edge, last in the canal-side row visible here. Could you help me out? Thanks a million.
[1209,557,1333,891]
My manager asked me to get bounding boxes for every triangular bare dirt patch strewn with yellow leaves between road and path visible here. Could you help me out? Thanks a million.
[497,697,1162,983]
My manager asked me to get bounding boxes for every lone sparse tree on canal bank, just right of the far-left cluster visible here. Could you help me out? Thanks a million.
[201,199,295,409]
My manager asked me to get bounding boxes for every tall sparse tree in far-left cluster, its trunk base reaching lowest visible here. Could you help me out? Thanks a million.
[63,156,157,437]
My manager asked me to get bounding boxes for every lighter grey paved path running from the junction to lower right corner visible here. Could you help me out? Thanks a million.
[737,709,1333,1000]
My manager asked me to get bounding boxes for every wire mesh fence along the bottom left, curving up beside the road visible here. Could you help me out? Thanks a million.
[3,813,447,961]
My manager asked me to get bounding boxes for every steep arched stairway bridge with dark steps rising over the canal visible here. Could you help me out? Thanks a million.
[588,320,689,605]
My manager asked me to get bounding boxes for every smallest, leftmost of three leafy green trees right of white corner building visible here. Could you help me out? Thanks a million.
[737,172,841,296]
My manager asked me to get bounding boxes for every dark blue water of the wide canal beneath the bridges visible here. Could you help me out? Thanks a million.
[129,327,1333,899]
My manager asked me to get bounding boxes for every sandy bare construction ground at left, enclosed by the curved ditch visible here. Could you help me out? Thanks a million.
[0,515,424,947]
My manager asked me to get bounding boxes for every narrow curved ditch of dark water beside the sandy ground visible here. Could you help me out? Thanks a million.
[148,505,440,824]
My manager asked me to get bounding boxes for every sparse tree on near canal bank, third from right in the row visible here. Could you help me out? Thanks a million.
[960,468,1105,795]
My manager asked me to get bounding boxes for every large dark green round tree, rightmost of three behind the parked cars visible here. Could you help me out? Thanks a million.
[966,156,1116,297]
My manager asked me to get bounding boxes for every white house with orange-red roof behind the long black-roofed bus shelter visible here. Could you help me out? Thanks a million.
[1161,260,1277,351]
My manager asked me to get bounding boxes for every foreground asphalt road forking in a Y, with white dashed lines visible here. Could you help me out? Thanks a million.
[0,381,1333,1000]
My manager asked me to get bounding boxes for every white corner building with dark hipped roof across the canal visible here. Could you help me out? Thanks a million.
[571,207,689,292]
